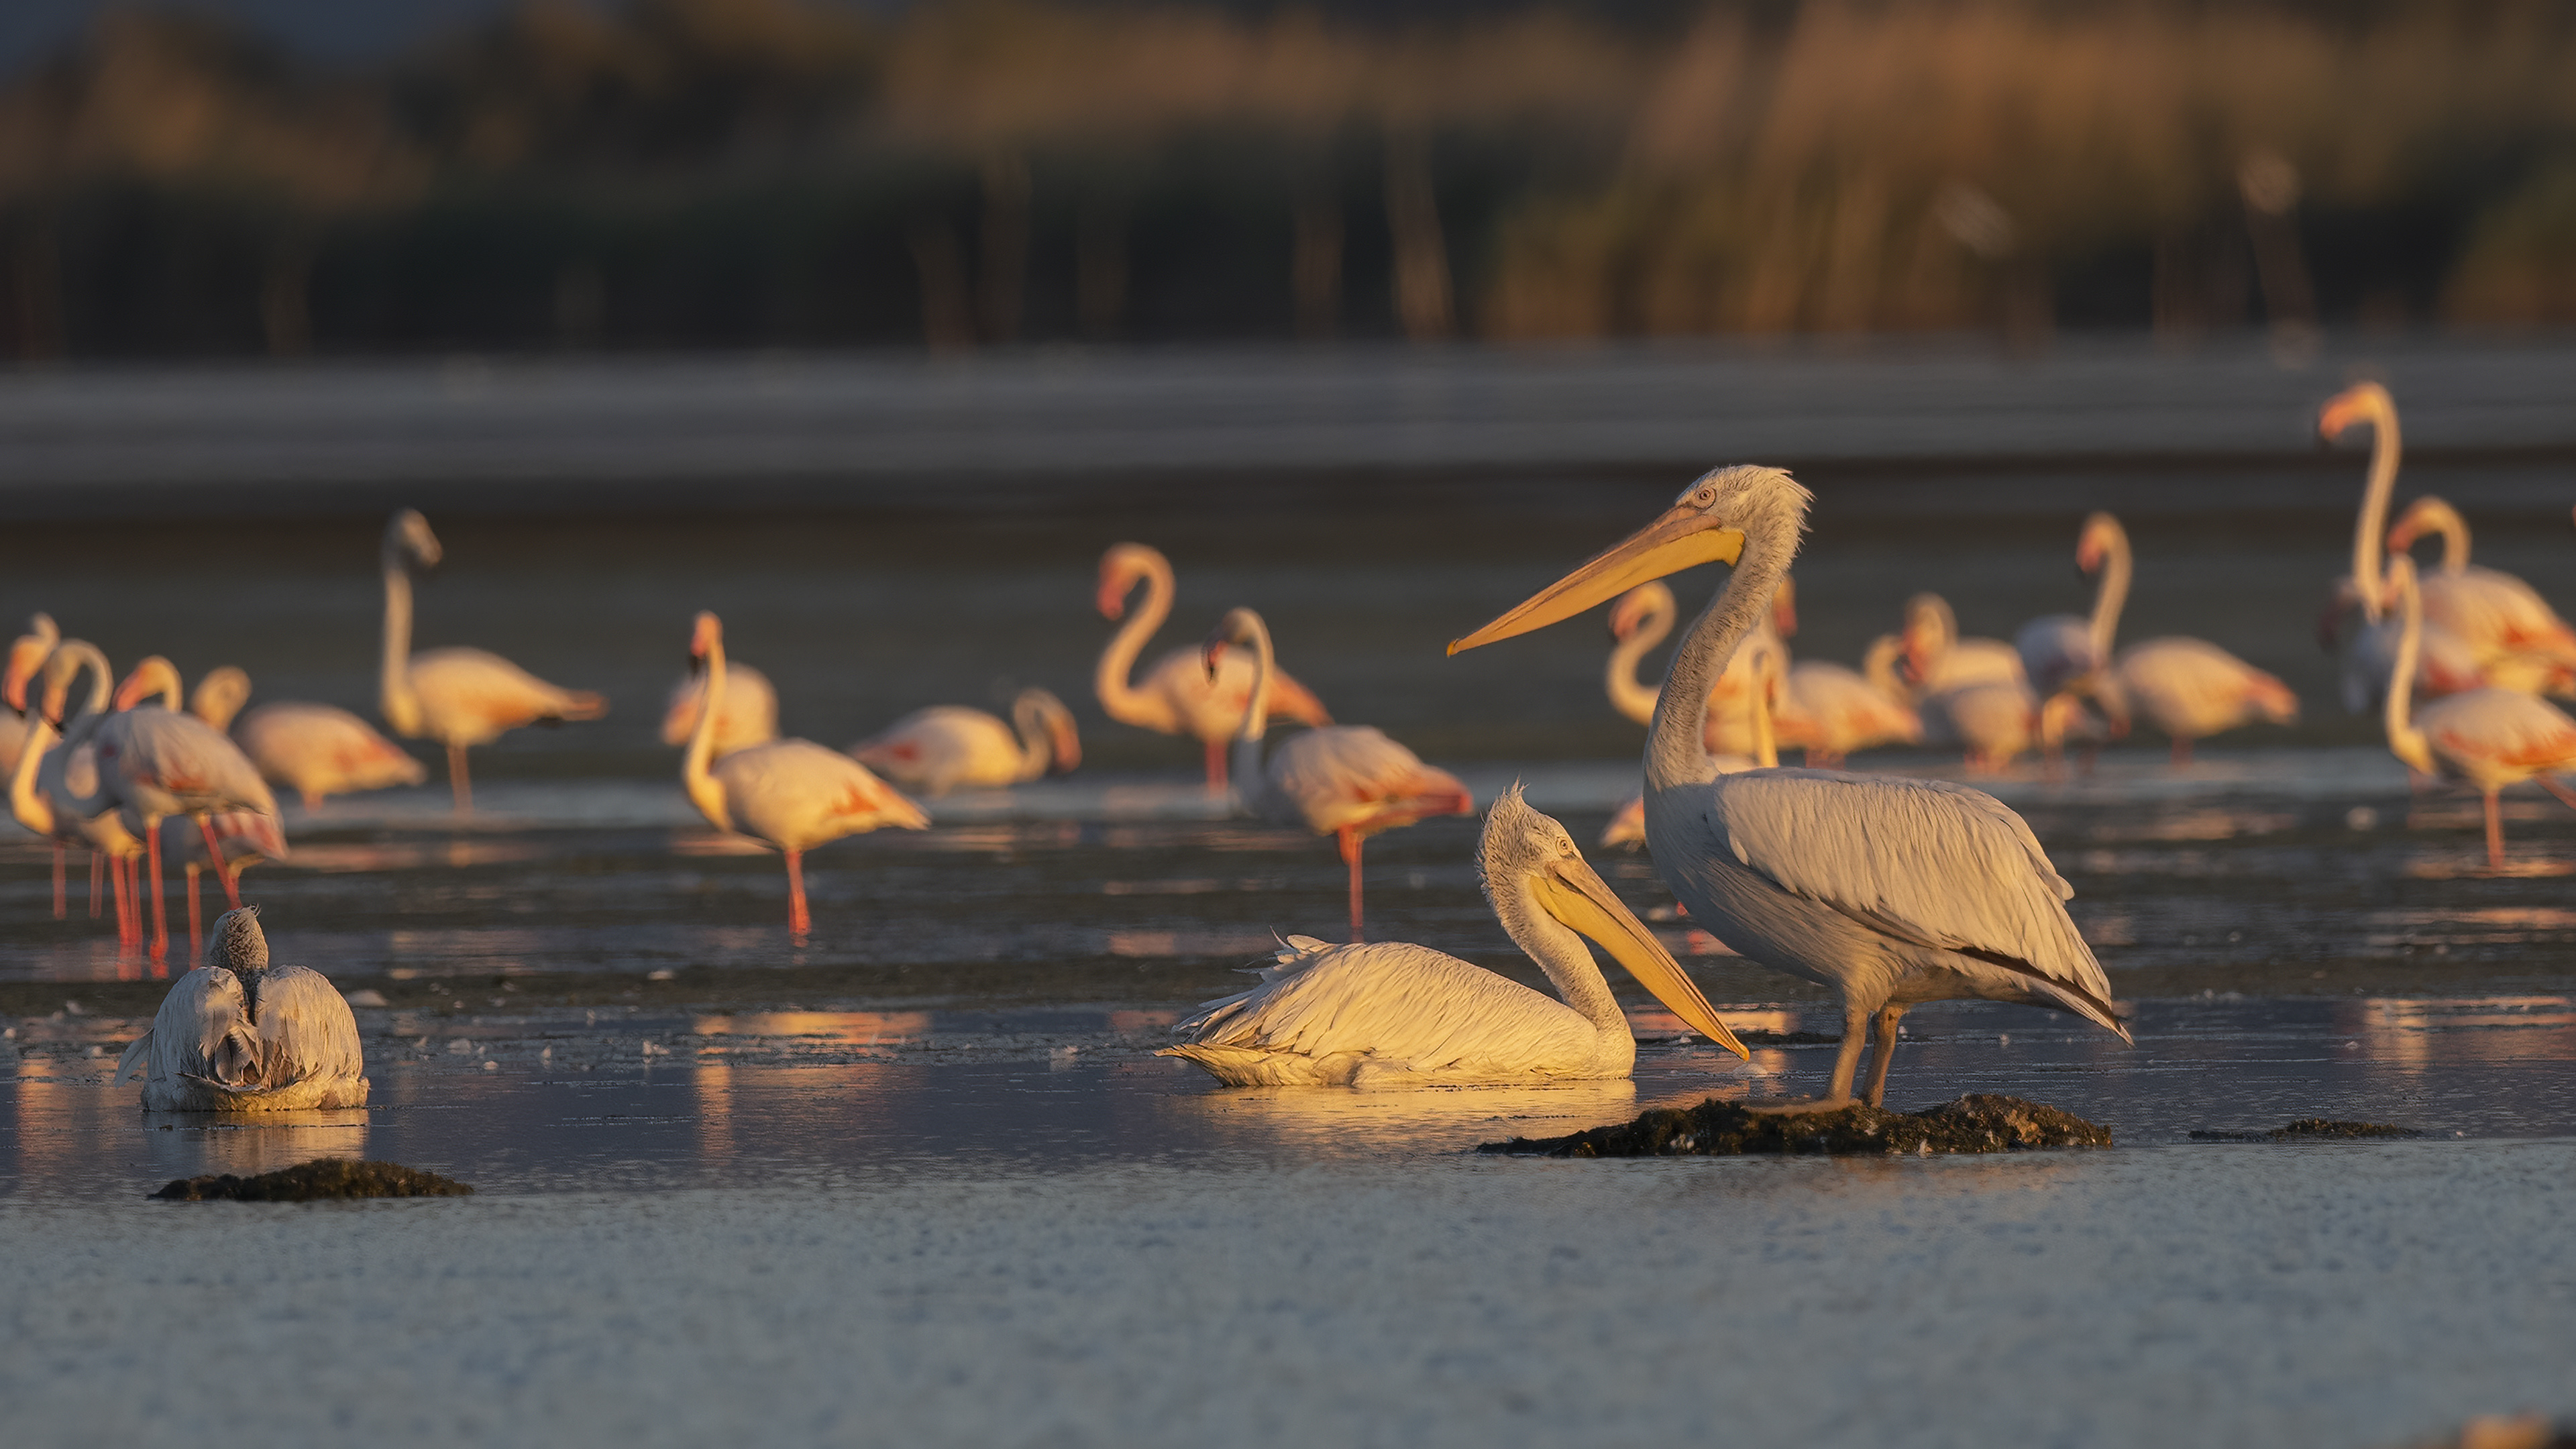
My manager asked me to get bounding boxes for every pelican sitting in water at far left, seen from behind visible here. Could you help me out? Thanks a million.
[116,905,366,1112]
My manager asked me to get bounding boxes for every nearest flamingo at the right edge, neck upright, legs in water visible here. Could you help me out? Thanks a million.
[2383,554,2576,869]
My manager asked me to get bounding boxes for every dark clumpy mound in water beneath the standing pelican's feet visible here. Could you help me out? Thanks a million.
[1476,1093,2110,1158]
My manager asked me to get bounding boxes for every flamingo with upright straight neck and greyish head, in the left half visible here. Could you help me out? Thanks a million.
[378,508,608,815]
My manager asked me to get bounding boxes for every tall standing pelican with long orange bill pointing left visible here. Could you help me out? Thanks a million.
[1450,467,2128,1112]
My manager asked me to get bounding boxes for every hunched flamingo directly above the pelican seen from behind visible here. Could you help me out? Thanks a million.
[74,655,278,962]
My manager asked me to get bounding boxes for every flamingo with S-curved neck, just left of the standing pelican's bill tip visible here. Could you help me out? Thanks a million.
[1092,544,1332,794]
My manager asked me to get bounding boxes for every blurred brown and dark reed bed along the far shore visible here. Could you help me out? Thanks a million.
[0,0,2576,356]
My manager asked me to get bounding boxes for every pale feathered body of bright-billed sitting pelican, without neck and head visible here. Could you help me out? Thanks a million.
[1172,936,1595,1080]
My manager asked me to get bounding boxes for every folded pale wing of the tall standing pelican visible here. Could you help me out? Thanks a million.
[1708,771,2120,1031]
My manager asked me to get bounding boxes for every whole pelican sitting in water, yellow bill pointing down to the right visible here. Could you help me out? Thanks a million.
[1159,786,1747,1088]
